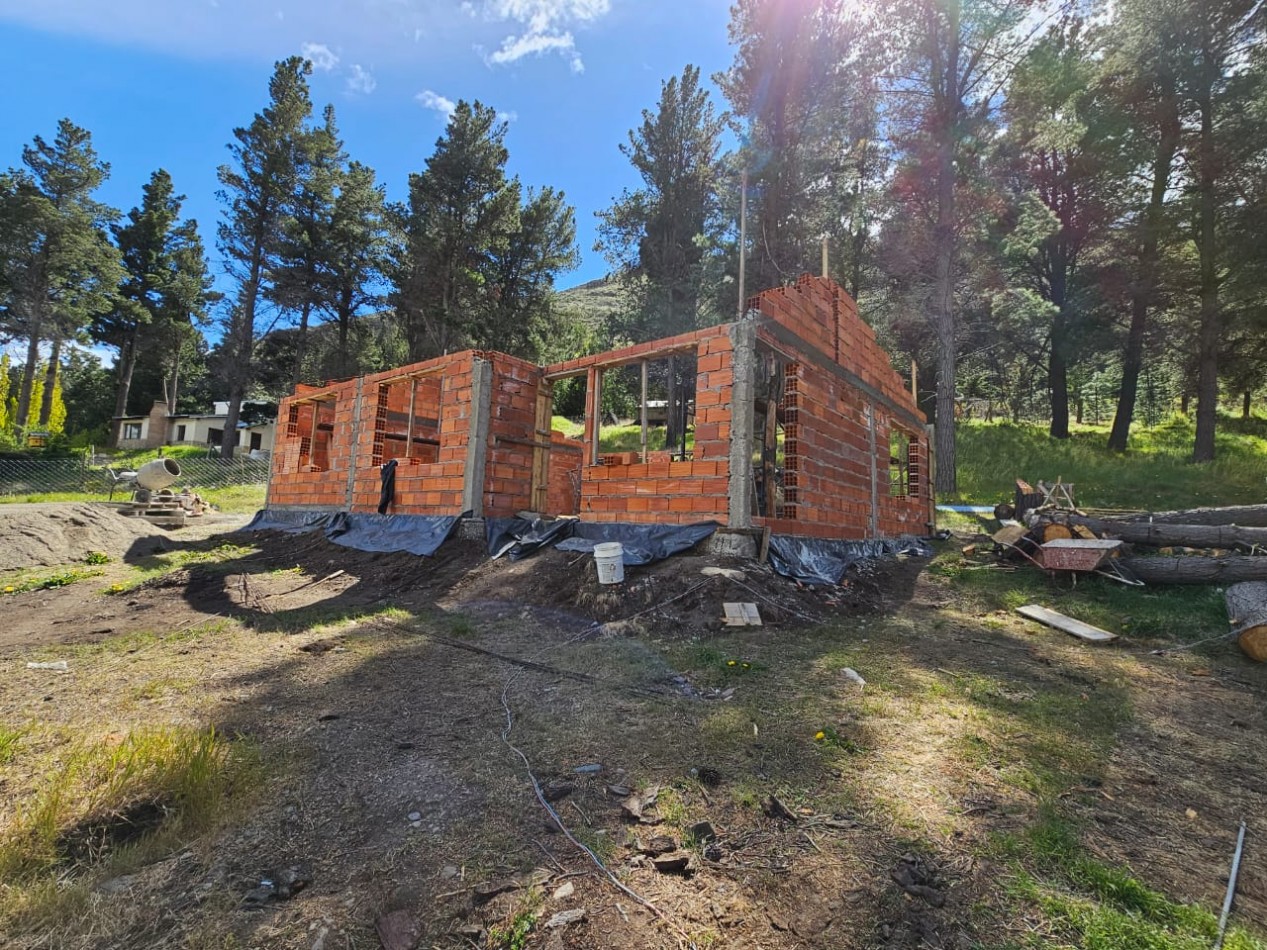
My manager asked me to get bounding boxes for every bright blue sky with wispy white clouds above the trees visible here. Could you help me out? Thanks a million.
[0,0,731,286]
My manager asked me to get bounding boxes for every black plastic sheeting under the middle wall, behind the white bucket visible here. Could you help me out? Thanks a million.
[485,518,720,567]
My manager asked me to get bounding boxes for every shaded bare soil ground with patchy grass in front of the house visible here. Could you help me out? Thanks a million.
[0,501,1267,950]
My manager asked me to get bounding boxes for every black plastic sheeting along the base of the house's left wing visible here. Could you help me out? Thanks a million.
[242,508,464,557]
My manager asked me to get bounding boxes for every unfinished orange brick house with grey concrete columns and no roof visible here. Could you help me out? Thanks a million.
[267,276,933,540]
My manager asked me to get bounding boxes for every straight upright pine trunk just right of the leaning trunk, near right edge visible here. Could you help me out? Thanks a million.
[1192,59,1221,462]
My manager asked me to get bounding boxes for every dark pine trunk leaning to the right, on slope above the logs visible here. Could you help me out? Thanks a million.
[1109,82,1187,452]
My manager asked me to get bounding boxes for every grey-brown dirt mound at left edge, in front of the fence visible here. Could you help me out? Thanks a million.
[0,503,197,571]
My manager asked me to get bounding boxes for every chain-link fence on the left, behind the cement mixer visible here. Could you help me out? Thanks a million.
[0,456,269,495]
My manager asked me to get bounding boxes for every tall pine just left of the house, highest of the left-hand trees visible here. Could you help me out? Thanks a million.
[218,56,312,459]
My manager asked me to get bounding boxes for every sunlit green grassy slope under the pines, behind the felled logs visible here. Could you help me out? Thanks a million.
[943,417,1267,510]
